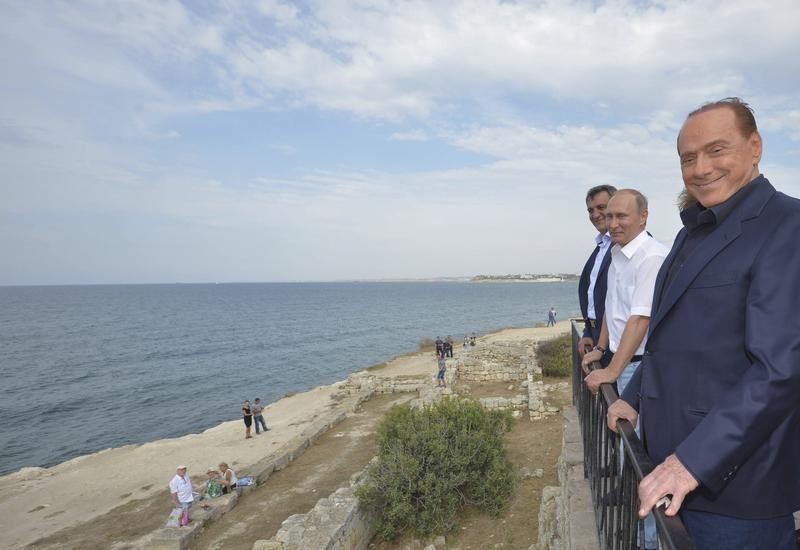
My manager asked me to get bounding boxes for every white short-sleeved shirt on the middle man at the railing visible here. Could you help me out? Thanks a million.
[606,231,669,355]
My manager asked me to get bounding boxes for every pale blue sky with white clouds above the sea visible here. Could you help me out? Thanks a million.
[0,0,800,284]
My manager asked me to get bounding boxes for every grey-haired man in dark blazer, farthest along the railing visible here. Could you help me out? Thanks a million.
[578,185,617,356]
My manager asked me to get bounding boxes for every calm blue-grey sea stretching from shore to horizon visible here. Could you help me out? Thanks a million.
[0,282,578,474]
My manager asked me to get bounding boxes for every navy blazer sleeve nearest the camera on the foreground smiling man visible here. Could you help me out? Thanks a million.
[676,213,800,492]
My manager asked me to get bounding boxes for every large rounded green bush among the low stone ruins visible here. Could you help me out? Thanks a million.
[356,399,513,540]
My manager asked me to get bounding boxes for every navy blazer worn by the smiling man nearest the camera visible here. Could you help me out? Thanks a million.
[623,176,800,519]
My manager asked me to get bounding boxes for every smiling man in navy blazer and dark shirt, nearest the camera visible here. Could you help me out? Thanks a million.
[608,98,800,550]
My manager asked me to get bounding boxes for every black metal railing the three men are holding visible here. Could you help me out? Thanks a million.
[572,320,695,550]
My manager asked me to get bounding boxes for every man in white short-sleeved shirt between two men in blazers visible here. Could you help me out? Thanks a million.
[582,189,668,392]
